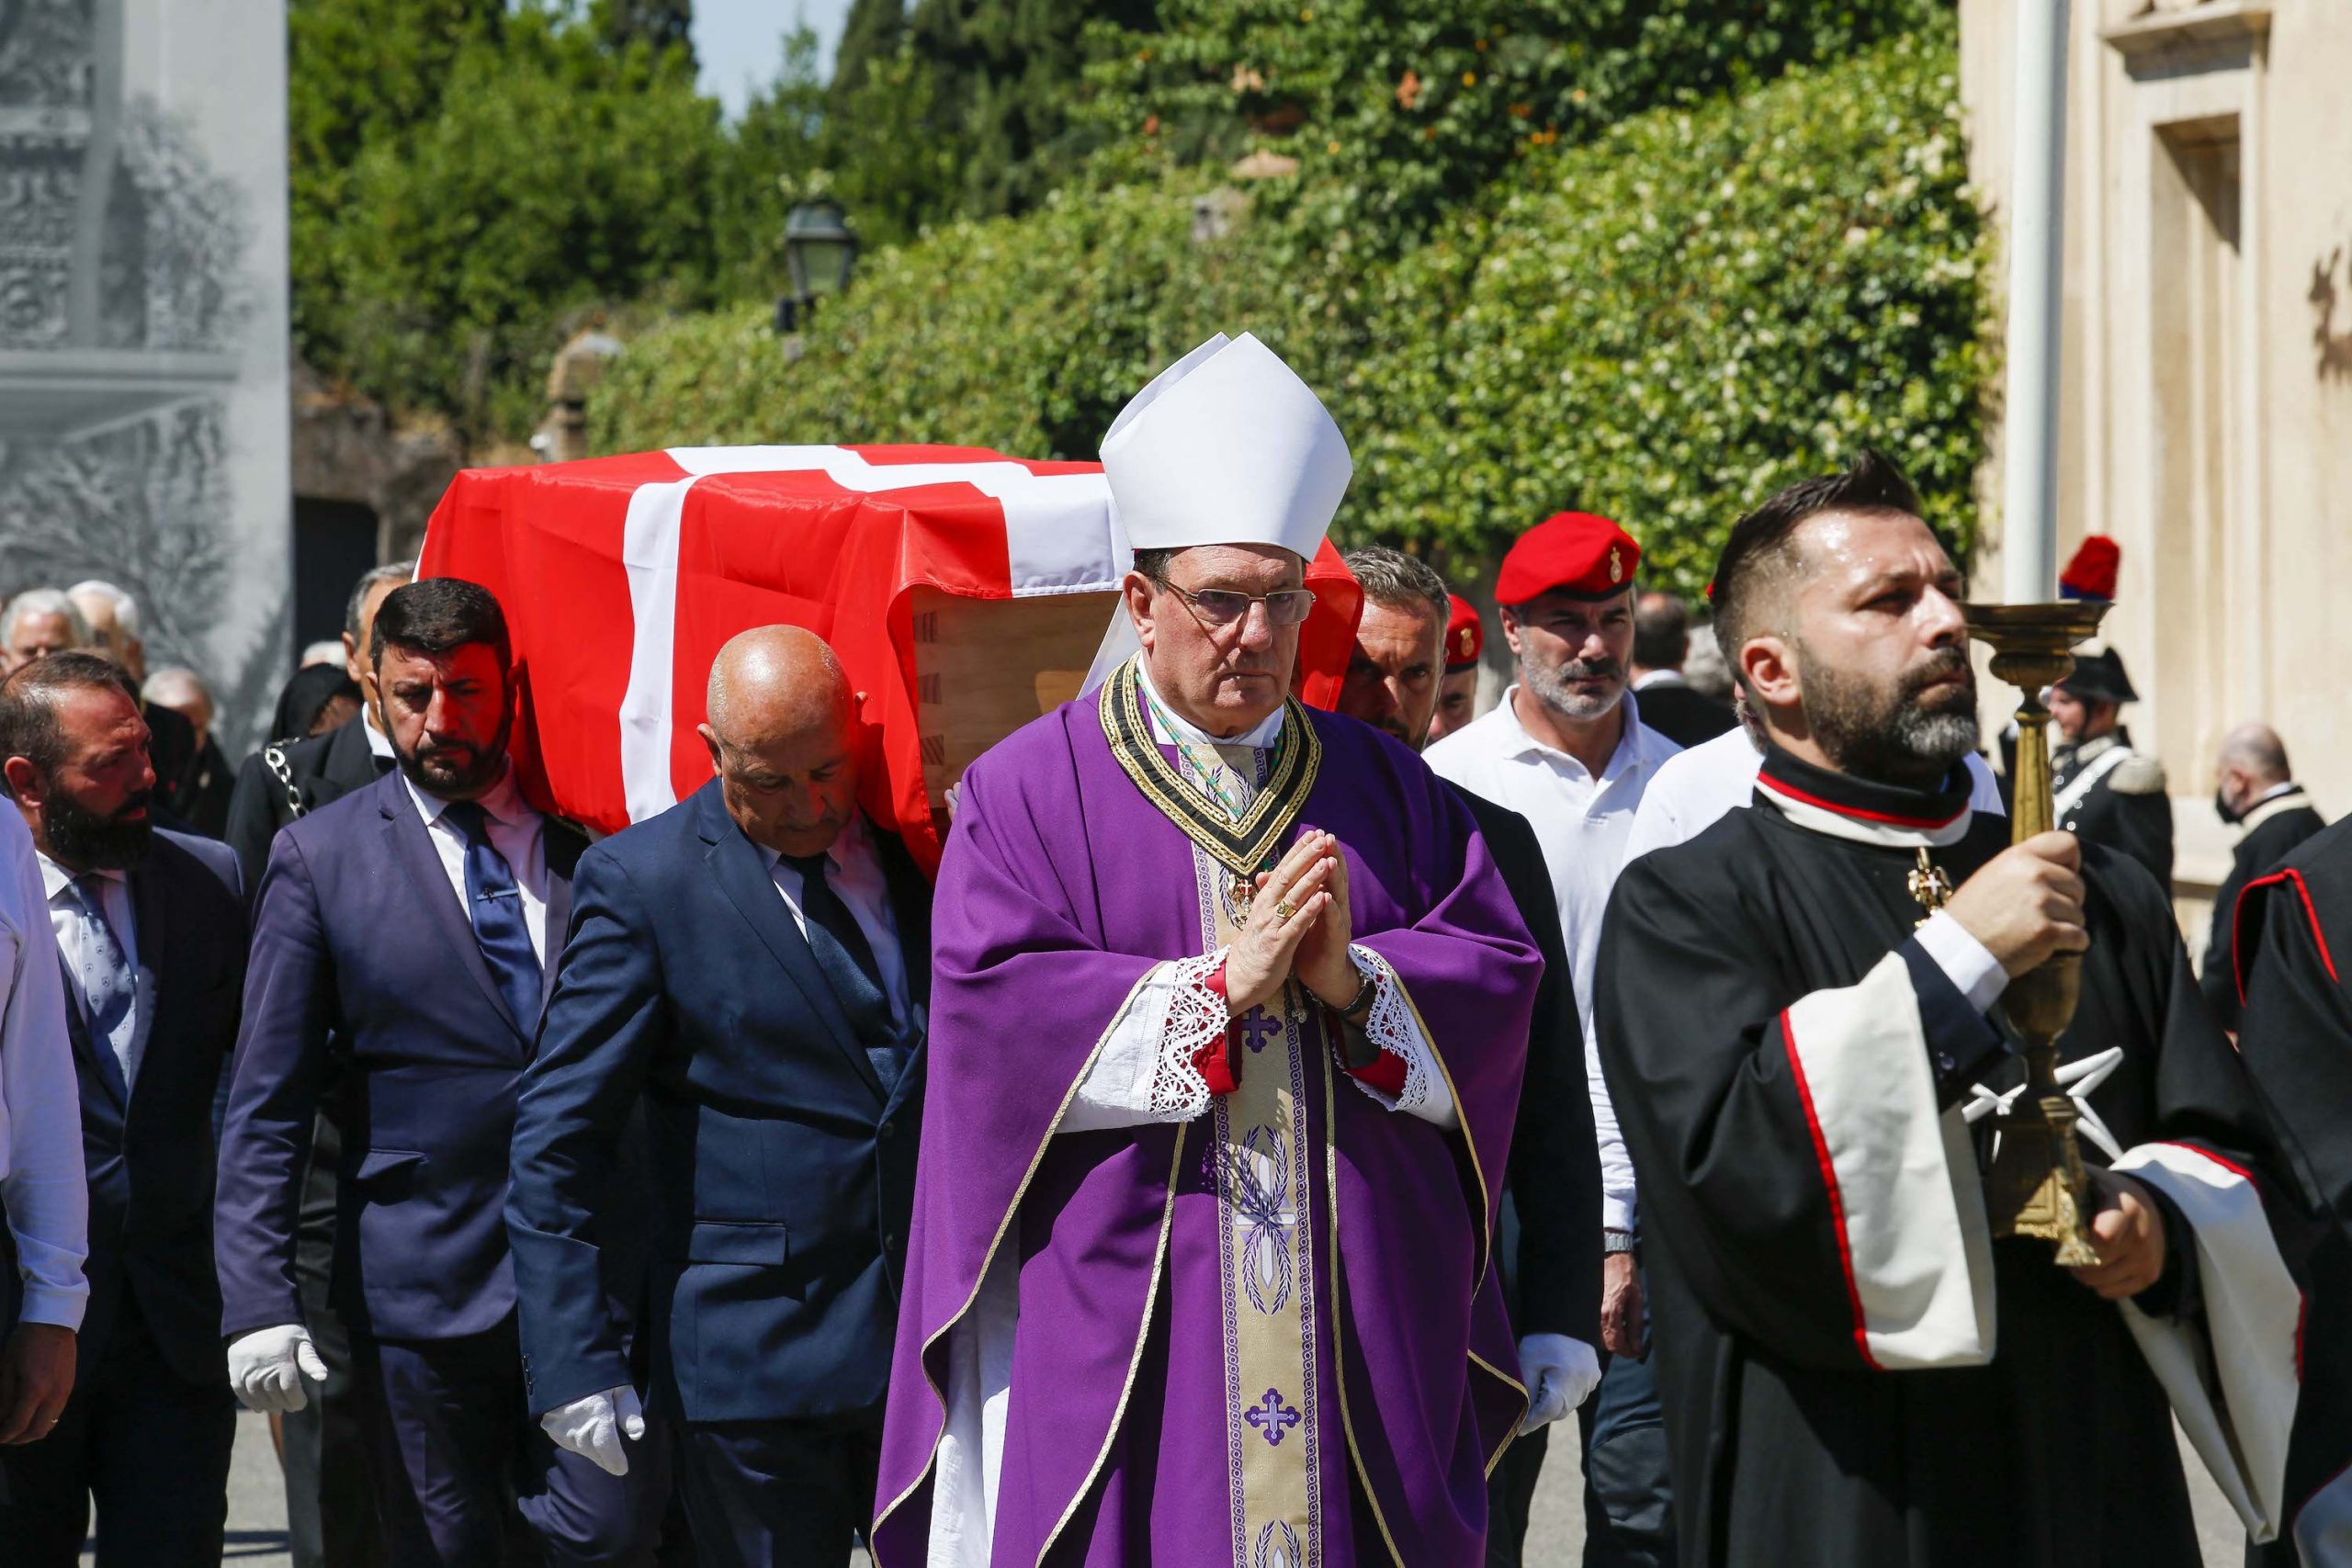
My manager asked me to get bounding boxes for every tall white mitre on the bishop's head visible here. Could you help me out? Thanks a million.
[1103,332,1355,559]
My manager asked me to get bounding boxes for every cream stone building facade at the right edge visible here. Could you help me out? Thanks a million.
[1959,0,2352,931]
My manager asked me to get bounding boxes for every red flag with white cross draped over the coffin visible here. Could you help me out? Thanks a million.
[419,446,1362,867]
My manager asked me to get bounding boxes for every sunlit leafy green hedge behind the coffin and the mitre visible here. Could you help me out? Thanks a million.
[591,24,1987,588]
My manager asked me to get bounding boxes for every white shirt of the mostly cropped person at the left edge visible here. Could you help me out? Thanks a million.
[0,811,89,1328]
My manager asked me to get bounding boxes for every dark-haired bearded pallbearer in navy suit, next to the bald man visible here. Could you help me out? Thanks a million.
[219,579,668,1568]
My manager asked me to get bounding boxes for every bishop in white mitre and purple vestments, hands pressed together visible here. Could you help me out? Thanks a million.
[873,336,1541,1568]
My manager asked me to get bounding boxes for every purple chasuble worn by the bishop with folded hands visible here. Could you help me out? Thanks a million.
[875,698,1543,1568]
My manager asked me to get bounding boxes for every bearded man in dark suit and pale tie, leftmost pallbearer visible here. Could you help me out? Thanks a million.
[0,653,244,1568]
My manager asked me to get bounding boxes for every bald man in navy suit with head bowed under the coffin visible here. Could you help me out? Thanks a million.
[508,626,932,1568]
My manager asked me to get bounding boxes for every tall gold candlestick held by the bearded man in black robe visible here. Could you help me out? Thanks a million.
[1964,602,2108,1267]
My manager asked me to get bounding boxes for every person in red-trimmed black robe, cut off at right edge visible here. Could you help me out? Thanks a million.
[2230,820,2352,1568]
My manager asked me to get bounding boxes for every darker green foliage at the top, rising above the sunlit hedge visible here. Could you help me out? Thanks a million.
[1084,0,1950,247]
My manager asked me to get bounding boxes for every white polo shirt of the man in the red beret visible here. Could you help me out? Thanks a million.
[1423,684,1681,1229]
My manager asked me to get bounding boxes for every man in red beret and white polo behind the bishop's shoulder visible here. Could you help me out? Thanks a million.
[1425,513,1677,1568]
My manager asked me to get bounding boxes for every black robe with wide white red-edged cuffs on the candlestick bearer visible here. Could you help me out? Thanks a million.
[1597,750,2301,1568]
